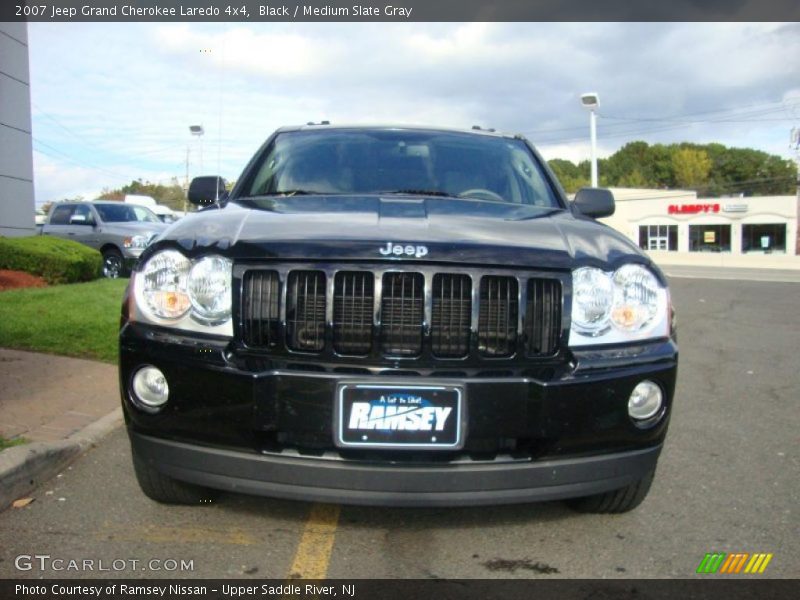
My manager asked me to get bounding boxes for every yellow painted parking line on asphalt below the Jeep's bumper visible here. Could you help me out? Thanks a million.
[289,504,340,579]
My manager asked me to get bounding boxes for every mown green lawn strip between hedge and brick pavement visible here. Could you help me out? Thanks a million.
[0,279,128,363]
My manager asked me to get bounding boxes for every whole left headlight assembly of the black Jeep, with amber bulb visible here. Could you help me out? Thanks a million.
[131,250,233,336]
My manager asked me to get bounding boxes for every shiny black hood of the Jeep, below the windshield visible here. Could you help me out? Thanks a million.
[145,196,650,269]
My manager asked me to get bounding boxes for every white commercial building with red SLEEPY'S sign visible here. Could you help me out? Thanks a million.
[603,188,800,256]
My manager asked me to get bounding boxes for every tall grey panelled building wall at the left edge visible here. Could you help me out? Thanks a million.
[0,23,36,236]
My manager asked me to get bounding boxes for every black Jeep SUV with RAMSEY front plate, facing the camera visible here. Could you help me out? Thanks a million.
[120,124,678,512]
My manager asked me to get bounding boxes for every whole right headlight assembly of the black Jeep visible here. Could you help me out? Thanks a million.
[569,264,669,346]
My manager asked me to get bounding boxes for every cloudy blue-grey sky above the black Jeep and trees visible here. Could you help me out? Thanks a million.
[28,23,800,203]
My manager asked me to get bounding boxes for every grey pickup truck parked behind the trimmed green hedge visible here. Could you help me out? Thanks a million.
[42,201,167,278]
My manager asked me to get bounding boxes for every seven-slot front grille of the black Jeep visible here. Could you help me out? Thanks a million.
[239,265,562,359]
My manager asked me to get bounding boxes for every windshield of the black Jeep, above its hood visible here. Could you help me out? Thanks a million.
[244,129,560,207]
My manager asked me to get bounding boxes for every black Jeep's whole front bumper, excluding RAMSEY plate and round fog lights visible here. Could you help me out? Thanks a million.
[120,323,677,506]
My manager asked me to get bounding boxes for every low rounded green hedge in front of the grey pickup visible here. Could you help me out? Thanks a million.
[0,236,103,283]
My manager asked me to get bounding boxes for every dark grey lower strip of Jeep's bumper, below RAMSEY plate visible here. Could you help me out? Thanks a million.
[130,431,661,506]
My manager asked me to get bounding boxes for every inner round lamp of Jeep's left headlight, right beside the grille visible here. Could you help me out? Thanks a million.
[189,256,232,325]
